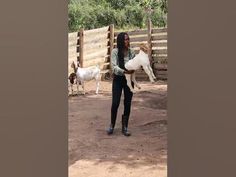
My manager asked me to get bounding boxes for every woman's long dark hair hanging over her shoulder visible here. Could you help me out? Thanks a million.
[117,32,129,70]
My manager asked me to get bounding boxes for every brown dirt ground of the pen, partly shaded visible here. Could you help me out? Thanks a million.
[68,81,167,177]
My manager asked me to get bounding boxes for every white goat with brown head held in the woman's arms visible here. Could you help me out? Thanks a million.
[125,44,156,92]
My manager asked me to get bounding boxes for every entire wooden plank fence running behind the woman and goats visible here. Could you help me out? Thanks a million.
[68,25,167,80]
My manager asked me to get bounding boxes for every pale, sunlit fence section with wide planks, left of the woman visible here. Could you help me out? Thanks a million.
[68,26,111,77]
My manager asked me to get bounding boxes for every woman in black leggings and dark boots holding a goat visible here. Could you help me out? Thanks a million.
[107,32,135,136]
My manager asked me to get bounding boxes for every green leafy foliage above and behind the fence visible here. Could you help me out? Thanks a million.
[68,0,168,32]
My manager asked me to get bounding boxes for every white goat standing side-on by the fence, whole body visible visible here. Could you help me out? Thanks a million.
[71,62,100,94]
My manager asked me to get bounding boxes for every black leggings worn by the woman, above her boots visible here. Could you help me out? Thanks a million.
[111,75,134,126]
